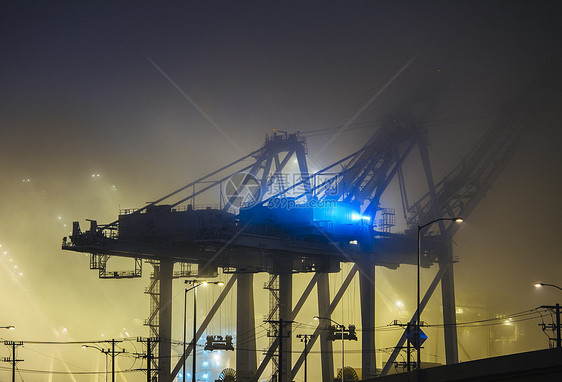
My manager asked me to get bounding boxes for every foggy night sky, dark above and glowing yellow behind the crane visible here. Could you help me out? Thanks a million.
[0,1,562,382]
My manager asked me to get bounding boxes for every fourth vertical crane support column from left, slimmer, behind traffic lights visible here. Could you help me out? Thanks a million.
[316,273,334,381]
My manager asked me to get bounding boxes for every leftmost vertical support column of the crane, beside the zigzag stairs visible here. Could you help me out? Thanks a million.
[158,260,174,381]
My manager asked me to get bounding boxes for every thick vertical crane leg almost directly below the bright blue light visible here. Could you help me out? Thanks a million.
[359,258,377,379]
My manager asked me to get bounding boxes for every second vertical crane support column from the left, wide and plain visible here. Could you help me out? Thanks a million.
[236,273,257,382]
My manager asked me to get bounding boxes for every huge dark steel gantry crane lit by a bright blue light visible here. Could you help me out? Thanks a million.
[63,71,548,382]
